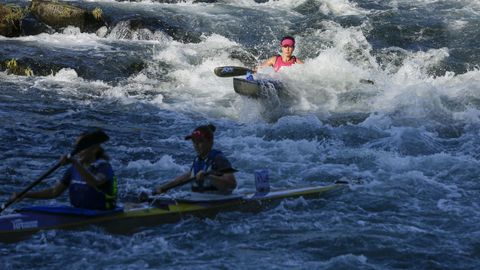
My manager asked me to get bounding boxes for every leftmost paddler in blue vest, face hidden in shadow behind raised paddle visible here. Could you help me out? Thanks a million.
[12,129,117,210]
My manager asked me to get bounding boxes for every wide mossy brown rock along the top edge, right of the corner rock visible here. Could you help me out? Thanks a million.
[30,0,106,32]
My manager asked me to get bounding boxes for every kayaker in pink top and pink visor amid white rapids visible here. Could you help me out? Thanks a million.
[257,36,303,75]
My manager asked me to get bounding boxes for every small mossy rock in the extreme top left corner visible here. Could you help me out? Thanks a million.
[0,4,26,37]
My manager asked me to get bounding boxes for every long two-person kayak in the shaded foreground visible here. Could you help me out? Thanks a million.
[0,184,344,242]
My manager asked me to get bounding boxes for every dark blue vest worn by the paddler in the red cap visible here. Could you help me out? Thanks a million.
[190,149,223,192]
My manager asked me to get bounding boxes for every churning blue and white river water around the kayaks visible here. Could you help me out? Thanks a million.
[0,0,480,269]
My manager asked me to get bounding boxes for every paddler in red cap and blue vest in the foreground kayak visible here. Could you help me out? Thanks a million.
[152,124,237,195]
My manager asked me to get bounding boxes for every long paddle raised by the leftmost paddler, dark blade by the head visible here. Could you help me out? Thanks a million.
[0,130,109,213]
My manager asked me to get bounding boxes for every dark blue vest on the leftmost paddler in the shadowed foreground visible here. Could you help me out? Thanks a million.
[68,160,118,210]
